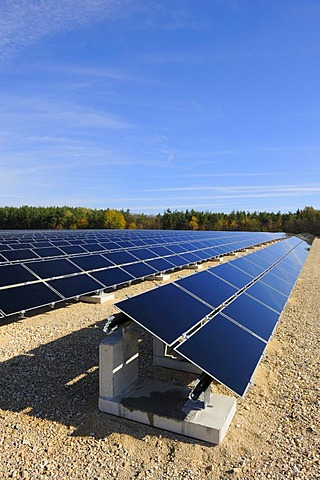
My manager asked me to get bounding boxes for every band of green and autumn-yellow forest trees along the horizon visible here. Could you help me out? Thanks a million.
[0,205,320,236]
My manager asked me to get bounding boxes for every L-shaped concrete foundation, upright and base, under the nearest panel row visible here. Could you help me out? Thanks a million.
[99,323,236,444]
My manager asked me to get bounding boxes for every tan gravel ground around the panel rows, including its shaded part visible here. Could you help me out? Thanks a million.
[0,239,320,480]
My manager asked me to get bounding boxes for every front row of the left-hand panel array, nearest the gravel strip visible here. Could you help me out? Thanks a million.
[0,232,284,316]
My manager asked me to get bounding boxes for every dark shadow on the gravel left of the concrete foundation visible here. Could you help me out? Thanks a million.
[0,321,205,444]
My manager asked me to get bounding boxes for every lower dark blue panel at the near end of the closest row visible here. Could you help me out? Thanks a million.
[176,315,266,396]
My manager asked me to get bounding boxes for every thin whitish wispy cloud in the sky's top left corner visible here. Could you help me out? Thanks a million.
[0,0,132,60]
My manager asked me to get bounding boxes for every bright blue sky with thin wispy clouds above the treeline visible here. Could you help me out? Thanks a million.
[0,0,320,213]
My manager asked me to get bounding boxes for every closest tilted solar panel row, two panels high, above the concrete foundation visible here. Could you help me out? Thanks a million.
[116,237,309,396]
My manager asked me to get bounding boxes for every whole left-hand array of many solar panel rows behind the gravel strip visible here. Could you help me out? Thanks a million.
[0,230,285,317]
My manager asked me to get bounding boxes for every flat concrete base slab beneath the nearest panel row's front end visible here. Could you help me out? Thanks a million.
[99,380,236,444]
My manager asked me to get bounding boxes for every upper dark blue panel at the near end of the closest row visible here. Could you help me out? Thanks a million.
[117,284,211,345]
